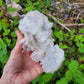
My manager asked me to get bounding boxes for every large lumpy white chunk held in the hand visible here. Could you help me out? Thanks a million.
[19,10,64,73]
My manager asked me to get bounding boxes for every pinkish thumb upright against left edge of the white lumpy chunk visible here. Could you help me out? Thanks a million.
[13,31,24,52]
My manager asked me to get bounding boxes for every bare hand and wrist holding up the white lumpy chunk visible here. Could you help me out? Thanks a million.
[0,31,61,84]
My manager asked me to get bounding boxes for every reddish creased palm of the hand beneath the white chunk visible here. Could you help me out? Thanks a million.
[11,51,42,84]
